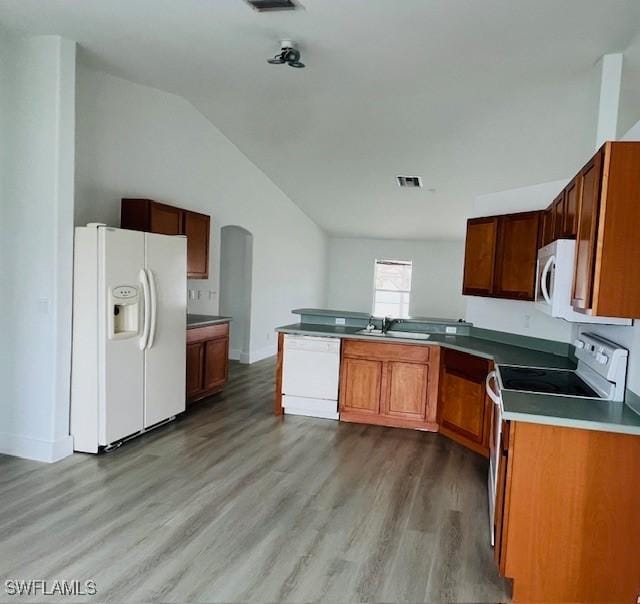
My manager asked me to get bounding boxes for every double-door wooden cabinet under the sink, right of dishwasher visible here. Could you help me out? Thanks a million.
[340,340,440,431]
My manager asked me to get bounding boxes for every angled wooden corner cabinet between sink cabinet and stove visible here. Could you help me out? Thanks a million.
[438,349,493,457]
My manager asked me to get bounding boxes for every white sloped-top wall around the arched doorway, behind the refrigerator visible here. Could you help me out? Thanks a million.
[76,66,326,360]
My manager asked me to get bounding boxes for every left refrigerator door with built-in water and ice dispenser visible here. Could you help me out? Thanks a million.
[98,228,145,445]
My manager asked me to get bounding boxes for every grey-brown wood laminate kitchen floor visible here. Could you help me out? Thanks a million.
[0,359,508,603]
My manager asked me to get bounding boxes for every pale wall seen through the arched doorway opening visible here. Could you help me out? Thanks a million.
[220,226,253,363]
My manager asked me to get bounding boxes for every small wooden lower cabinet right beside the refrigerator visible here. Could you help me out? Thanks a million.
[187,323,229,403]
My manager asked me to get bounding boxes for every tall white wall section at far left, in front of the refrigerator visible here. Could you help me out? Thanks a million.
[0,34,75,461]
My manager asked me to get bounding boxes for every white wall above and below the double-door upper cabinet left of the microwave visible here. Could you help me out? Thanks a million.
[466,179,573,342]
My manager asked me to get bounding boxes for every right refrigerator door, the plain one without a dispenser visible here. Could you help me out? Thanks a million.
[144,233,187,428]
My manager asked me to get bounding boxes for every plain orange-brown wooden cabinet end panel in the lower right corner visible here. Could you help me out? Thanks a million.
[496,422,640,603]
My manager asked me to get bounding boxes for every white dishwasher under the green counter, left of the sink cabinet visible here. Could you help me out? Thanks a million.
[282,335,340,419]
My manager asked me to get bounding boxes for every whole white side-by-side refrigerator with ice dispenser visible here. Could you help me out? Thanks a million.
[71,224,187,453]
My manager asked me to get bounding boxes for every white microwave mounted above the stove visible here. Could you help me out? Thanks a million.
[535,239,631,325]
